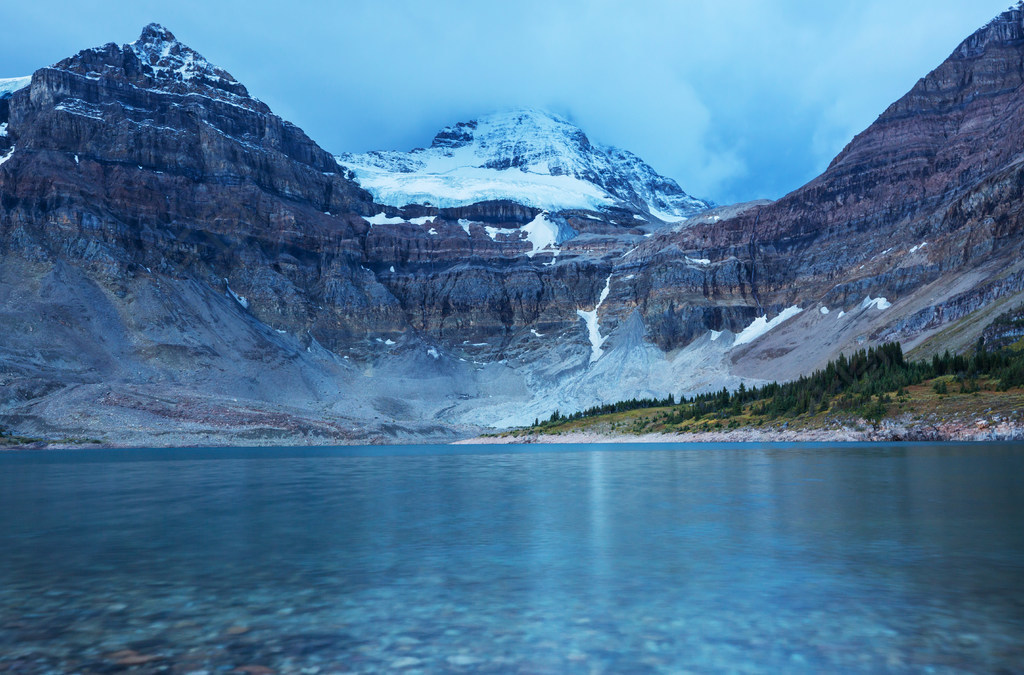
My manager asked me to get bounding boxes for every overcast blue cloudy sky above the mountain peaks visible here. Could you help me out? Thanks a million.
[0,0,1010,204]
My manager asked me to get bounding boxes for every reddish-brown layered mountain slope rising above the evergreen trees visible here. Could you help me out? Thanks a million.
[622,4,1024,378]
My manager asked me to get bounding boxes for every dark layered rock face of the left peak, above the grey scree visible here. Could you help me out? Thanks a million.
[0,27,394,344]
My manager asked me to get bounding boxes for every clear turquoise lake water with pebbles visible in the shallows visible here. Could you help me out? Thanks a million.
[0,444,1024,675]
